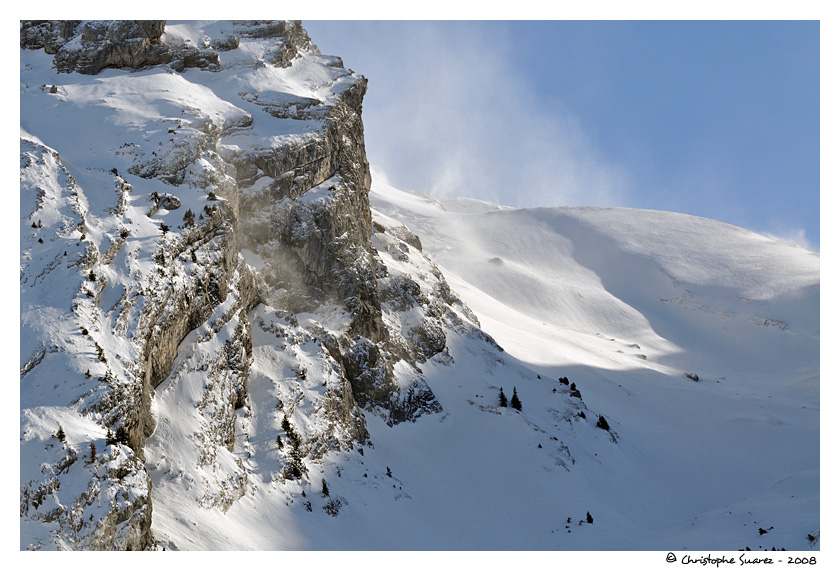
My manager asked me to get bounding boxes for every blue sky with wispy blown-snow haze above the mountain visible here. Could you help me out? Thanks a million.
[304,20,820,251]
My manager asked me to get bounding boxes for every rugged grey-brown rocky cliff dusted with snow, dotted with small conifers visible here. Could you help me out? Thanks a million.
[20,21,477,549]
